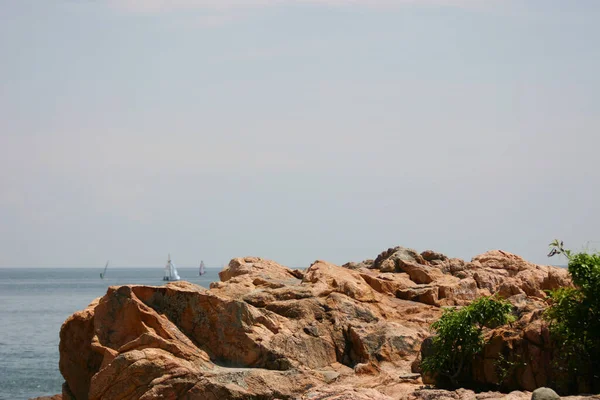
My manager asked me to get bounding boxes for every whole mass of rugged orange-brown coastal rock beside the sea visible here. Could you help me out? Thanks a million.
[60,247,580,400]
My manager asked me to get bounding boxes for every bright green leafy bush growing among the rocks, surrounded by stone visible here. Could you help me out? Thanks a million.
[421,297,512,386]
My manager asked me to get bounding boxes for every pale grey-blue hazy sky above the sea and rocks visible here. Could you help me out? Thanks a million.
[0,0,600,268]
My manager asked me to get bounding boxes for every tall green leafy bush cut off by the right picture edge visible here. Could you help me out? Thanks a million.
[545,240,600,392]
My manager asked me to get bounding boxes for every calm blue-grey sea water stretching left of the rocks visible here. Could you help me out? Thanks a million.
[0,267,220,400]
